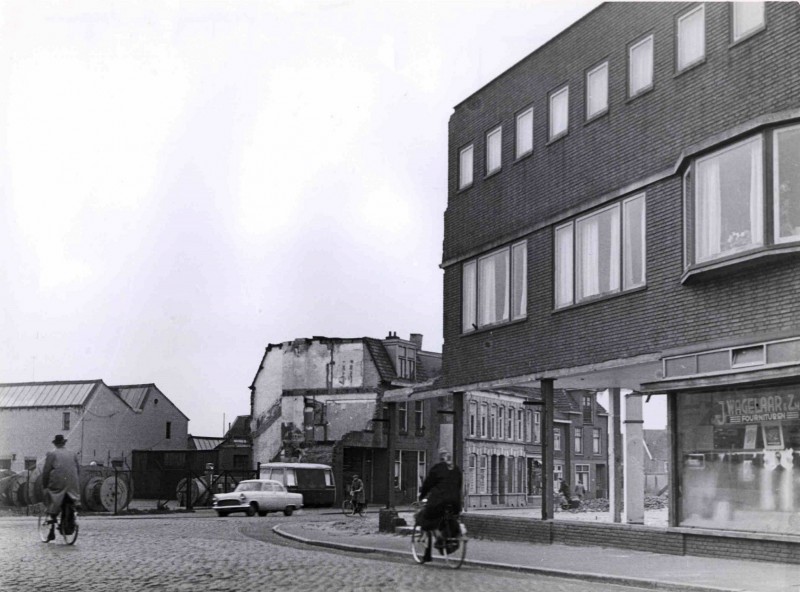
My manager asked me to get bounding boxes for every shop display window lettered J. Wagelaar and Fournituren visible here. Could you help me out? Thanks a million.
[677,386,800,535]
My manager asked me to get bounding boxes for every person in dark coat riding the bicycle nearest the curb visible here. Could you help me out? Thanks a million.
[417,448,463,563]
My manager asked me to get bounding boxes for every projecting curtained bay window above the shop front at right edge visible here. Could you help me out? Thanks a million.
[684,125,800,265]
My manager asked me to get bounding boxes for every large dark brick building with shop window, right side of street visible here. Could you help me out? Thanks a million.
[440,2,800,535]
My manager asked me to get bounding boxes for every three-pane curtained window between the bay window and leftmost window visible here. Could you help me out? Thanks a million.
[554,193,646,308]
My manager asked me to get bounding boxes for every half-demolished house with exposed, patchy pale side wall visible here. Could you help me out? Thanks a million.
[250,333,446,503]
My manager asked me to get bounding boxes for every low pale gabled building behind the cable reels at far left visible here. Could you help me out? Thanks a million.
[0,380,189,471]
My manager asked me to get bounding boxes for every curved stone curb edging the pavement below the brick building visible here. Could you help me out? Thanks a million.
[272,524,743,592]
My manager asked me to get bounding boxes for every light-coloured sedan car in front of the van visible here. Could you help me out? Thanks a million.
[211,479,303,516]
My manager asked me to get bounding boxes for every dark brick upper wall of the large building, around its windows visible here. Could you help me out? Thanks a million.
[443,3,800,386]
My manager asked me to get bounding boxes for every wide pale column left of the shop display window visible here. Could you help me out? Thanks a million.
[625,393,644,524]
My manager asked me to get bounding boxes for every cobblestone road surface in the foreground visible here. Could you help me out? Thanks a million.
[0,511,656,592]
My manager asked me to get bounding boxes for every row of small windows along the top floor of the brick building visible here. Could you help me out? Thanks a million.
[458,2,765,189]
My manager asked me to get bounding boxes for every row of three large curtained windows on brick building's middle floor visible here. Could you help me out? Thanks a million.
[462,120,800,324]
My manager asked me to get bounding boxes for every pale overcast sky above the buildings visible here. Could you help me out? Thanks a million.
[0,0,668,436]
